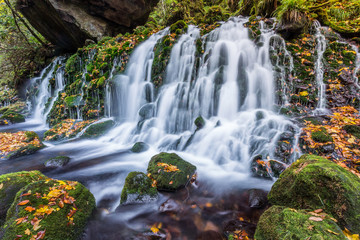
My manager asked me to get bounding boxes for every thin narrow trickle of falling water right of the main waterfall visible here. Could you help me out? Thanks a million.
[314,21,326,112]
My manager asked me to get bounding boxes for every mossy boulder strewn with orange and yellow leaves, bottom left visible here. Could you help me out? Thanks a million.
[0,180,95,240]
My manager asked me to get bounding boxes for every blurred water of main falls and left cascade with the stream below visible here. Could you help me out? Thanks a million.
[0,18,304,239]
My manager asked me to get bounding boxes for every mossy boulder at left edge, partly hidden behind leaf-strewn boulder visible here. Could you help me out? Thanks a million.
[0,171,47,226]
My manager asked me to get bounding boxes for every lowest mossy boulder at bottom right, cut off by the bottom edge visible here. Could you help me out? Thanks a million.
[255,206,347,240]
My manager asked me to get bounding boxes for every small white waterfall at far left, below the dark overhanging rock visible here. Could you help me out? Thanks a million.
[30,57,65,126]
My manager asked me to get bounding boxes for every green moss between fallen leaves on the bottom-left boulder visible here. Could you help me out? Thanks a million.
[2,180,95,240]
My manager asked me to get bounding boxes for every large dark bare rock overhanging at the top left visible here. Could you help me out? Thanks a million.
[17,0,158,51]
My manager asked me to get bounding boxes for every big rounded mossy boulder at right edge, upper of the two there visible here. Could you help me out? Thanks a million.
[268,155,360,232]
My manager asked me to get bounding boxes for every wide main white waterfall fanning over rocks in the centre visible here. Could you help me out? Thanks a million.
[101,18,297,171]
